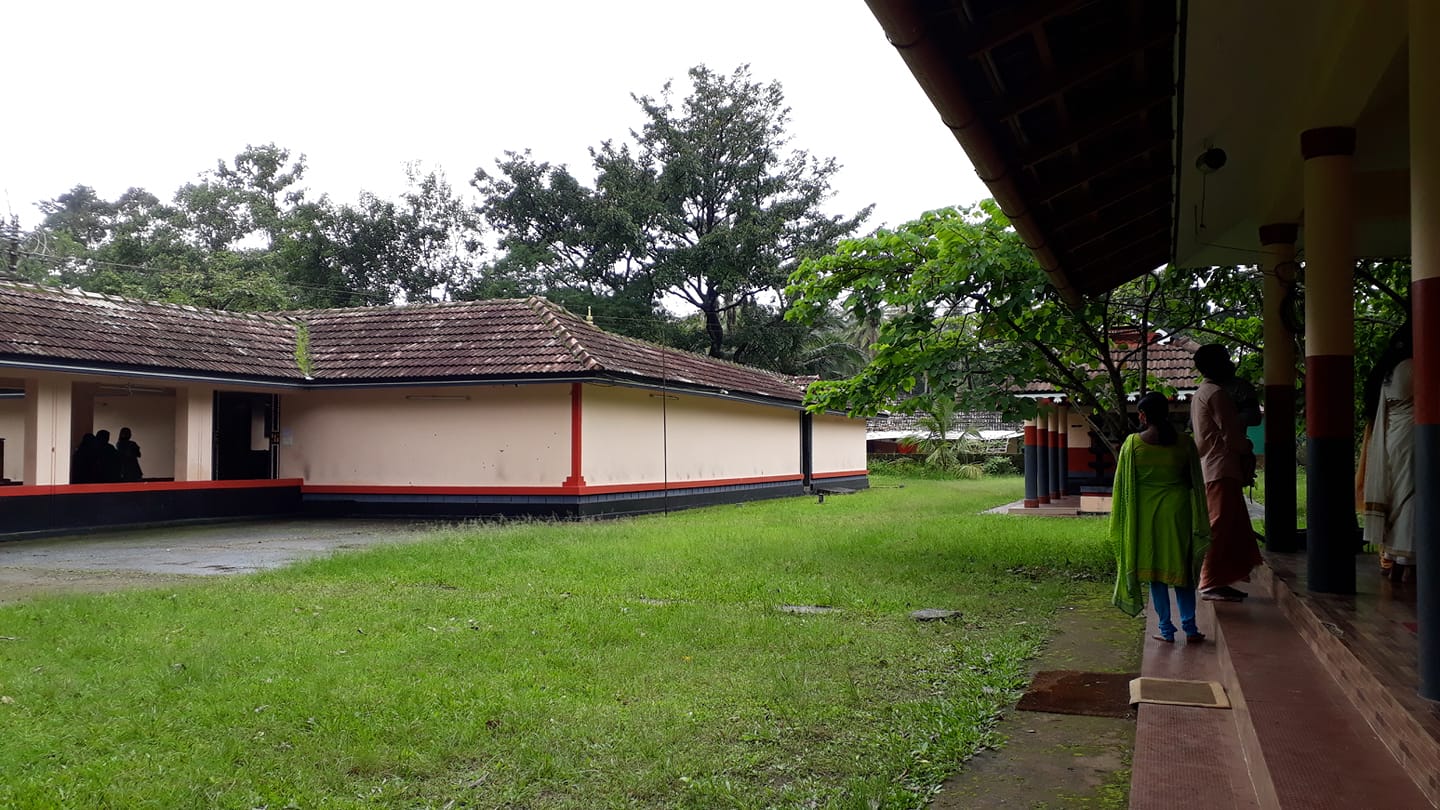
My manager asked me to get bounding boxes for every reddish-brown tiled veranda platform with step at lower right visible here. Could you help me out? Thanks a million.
[1130,555,1440,809]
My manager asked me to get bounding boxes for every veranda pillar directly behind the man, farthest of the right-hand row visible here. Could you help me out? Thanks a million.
[1260,222,1297,552]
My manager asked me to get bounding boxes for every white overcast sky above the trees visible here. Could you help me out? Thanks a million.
[0,0,986,231]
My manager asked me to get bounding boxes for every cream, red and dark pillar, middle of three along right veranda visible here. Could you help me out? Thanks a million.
[1300,127,1358,594]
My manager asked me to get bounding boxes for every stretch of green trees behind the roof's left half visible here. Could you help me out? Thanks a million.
[19,144,481,310]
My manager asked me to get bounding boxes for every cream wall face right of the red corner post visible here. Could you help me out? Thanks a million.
[582,385,800,486]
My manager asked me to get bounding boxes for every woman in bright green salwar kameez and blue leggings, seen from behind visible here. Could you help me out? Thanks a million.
[1110,392,1210,641]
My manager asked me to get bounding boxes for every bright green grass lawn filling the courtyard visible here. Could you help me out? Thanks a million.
[0,477,1112,810]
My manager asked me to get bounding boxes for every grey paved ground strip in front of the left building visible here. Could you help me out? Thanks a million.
[0,520,435,604]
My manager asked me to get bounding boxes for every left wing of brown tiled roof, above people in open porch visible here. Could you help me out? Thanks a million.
[0,282,304,379]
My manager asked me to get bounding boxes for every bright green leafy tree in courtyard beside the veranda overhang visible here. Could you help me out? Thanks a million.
[789,200,1226,444]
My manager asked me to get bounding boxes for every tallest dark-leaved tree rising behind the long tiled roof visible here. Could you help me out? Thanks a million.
[475,66,870,360]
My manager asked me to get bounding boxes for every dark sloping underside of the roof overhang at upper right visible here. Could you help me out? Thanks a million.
[868,0,1179,300]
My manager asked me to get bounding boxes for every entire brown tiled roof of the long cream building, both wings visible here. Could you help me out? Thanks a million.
[0,282,804,402]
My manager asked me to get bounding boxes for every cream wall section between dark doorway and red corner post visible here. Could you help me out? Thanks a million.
[279,385,570,486]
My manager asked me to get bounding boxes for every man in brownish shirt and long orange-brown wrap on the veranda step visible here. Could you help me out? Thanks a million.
[1189,343,1261,601]
